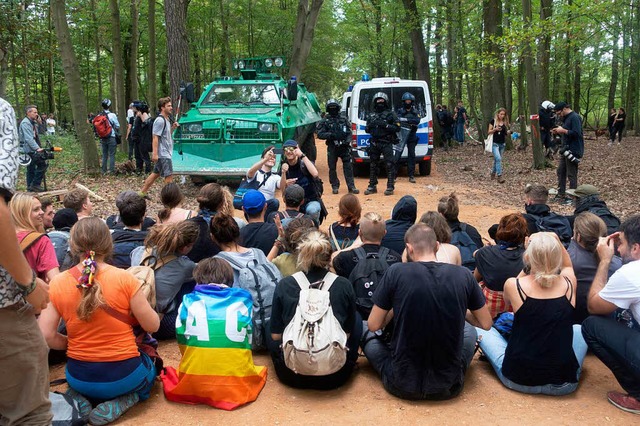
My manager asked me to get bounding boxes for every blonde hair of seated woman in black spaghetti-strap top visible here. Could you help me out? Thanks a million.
[524,232,562,288]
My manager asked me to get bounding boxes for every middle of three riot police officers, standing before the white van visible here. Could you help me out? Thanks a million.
[364,92,400,195]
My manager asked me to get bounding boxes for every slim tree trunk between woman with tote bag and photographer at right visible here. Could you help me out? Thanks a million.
[522,0,545,169]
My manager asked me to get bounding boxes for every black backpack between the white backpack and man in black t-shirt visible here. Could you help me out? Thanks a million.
[349,247,389,320]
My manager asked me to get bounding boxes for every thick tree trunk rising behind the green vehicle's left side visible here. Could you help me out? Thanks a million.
[164,0,191,105]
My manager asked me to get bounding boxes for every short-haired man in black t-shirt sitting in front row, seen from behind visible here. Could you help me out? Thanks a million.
[361,223,491,400]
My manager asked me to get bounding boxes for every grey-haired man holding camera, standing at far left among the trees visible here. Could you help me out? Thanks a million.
[18,105,48,192]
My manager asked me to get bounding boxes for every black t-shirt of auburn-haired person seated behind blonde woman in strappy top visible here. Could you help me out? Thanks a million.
[476,245,524,291]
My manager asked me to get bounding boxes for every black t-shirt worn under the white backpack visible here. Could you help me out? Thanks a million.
[271,268,356,334]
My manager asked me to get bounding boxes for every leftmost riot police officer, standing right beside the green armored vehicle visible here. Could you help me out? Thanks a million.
[317,99,360,194]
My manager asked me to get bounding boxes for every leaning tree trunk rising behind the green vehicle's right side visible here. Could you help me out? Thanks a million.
[289,0,322,79]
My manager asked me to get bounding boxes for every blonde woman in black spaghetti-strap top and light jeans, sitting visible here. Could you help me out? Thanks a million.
[478,232,587,395]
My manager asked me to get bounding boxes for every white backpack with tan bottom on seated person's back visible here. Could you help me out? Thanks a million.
[282,272,347,376]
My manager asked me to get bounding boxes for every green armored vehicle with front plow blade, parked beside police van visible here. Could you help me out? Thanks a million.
[173,57,321,181]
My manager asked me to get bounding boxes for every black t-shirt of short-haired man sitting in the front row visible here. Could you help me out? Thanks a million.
[373,262,485,394]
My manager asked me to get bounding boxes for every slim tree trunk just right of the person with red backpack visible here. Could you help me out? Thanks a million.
[109,0,128,152]
